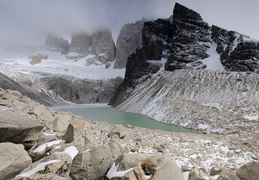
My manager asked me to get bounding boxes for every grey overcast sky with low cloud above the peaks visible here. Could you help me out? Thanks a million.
[0,0,259,44]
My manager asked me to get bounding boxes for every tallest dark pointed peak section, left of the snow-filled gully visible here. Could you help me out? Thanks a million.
[165,4,210,71]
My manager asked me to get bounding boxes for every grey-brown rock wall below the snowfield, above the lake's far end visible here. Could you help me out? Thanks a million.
[32,76,122,104]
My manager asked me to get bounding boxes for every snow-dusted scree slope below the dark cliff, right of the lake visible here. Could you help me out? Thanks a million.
[116,70,259,132]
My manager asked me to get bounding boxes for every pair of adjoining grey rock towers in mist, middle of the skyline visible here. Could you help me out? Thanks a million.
[66,29,115,65]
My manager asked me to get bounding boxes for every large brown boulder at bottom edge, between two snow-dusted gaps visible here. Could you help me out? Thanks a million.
[69,145,113,180]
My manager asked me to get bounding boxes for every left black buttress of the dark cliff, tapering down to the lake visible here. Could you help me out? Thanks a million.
[110,19,171,105]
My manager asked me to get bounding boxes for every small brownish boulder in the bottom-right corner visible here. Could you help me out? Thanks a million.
[236,161,259,180]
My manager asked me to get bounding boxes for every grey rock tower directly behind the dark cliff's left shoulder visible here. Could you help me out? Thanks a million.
[114,20,144,69]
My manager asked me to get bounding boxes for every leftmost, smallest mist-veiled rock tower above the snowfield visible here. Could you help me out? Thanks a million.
[44,34,70,53]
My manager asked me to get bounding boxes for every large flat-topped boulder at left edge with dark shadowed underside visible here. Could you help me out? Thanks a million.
[0,111,43,149]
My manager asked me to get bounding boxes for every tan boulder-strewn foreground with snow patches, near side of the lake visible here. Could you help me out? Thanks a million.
[0,89,259,180]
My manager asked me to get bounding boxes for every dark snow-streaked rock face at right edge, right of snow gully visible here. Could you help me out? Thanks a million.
[212,26,259,71]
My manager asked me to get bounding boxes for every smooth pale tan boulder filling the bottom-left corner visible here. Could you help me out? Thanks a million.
[0,142,32,180]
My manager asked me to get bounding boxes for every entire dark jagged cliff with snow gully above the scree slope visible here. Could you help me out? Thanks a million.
[110,3,259,106]
